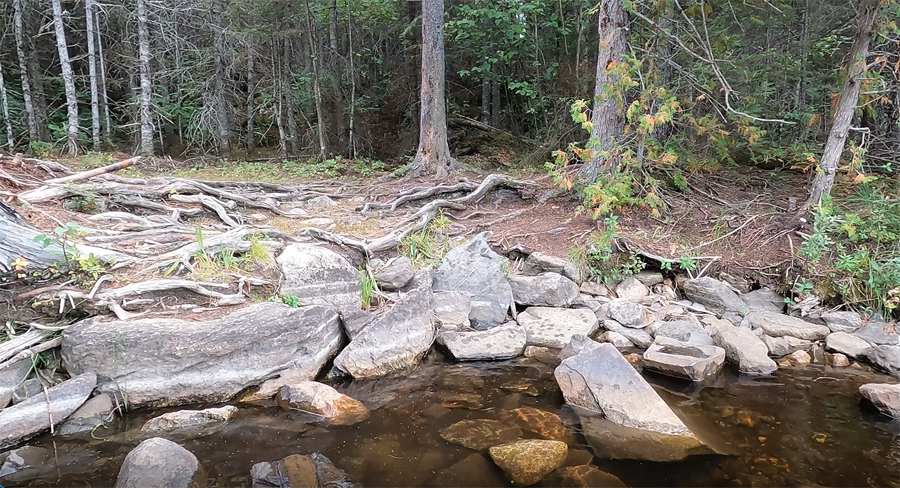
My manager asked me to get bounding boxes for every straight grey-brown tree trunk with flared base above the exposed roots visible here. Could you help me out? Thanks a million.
[409,0,459,178]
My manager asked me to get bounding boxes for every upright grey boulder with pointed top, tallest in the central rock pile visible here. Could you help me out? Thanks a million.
[433,233,512,325]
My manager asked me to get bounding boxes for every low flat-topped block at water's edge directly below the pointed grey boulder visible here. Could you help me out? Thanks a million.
[438,322,526,361]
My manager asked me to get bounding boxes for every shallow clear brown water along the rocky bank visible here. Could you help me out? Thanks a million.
[3,355,900,488]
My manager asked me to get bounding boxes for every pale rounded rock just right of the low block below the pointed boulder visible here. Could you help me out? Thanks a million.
[518,307,599,347]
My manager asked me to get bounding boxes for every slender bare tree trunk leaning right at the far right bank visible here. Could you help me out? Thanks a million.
[800,0,879,213]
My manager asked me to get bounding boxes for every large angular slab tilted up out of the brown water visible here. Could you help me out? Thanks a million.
[554,343,693,437]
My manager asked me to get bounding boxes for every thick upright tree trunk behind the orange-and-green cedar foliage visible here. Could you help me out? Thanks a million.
[578,0,628,183]
